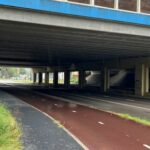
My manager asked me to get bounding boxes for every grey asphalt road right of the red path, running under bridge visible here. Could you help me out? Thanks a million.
[40,90,150,120]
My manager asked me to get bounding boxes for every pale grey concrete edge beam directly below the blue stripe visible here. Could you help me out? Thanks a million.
[0,6,150,37]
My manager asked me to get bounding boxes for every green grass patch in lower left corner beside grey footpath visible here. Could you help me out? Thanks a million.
[0,104,22,150]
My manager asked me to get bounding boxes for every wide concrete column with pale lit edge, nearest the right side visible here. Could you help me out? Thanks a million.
[135,64,145,96]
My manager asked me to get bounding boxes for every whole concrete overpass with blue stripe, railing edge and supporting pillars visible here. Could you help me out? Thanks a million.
[0,0,150,96]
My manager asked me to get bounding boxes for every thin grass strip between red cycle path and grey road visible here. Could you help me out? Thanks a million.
[115,113,150,126]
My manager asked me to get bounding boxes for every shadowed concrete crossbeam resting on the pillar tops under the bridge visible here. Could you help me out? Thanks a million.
[44,57,150,71]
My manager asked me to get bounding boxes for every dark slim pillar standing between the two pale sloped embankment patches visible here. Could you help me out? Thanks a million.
[101,67,110,93]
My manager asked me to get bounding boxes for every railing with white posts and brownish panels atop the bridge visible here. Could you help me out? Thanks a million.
[63,0,150,14]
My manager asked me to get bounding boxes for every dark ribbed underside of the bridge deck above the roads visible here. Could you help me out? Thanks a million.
[0,21,150,66]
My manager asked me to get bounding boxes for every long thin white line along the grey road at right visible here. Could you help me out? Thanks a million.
[72,94,150,111]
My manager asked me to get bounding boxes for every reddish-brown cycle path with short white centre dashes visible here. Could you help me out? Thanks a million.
[7,90,150,150]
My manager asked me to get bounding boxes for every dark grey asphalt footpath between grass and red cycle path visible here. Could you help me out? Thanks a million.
[0,91,83,150]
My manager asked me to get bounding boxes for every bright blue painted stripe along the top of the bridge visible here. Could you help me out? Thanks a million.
[0,0,150,26]
